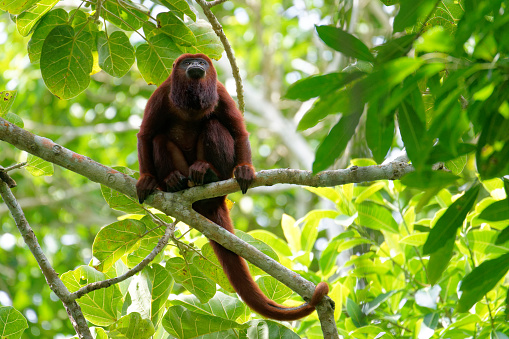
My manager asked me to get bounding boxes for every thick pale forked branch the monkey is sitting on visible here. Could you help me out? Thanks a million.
[0,118,413,338]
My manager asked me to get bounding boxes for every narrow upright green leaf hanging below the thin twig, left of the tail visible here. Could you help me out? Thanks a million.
[144,264,174,328]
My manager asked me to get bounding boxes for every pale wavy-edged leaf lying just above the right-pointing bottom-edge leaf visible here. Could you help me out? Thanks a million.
[172,291,246,321]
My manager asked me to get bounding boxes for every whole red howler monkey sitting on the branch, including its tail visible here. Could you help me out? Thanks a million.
[136,54,329,320]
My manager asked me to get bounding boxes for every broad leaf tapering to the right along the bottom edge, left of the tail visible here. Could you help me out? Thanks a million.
[163,306,244,339]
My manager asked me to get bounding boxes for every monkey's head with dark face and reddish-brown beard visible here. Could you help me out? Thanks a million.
[170,53,218,115]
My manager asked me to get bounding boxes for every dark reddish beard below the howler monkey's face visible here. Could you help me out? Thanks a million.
[171,79,218,112]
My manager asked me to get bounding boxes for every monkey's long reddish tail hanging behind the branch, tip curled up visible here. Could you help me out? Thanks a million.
[193,198,329,321]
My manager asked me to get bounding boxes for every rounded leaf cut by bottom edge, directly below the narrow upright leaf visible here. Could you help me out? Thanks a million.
[108,312,155,339]
